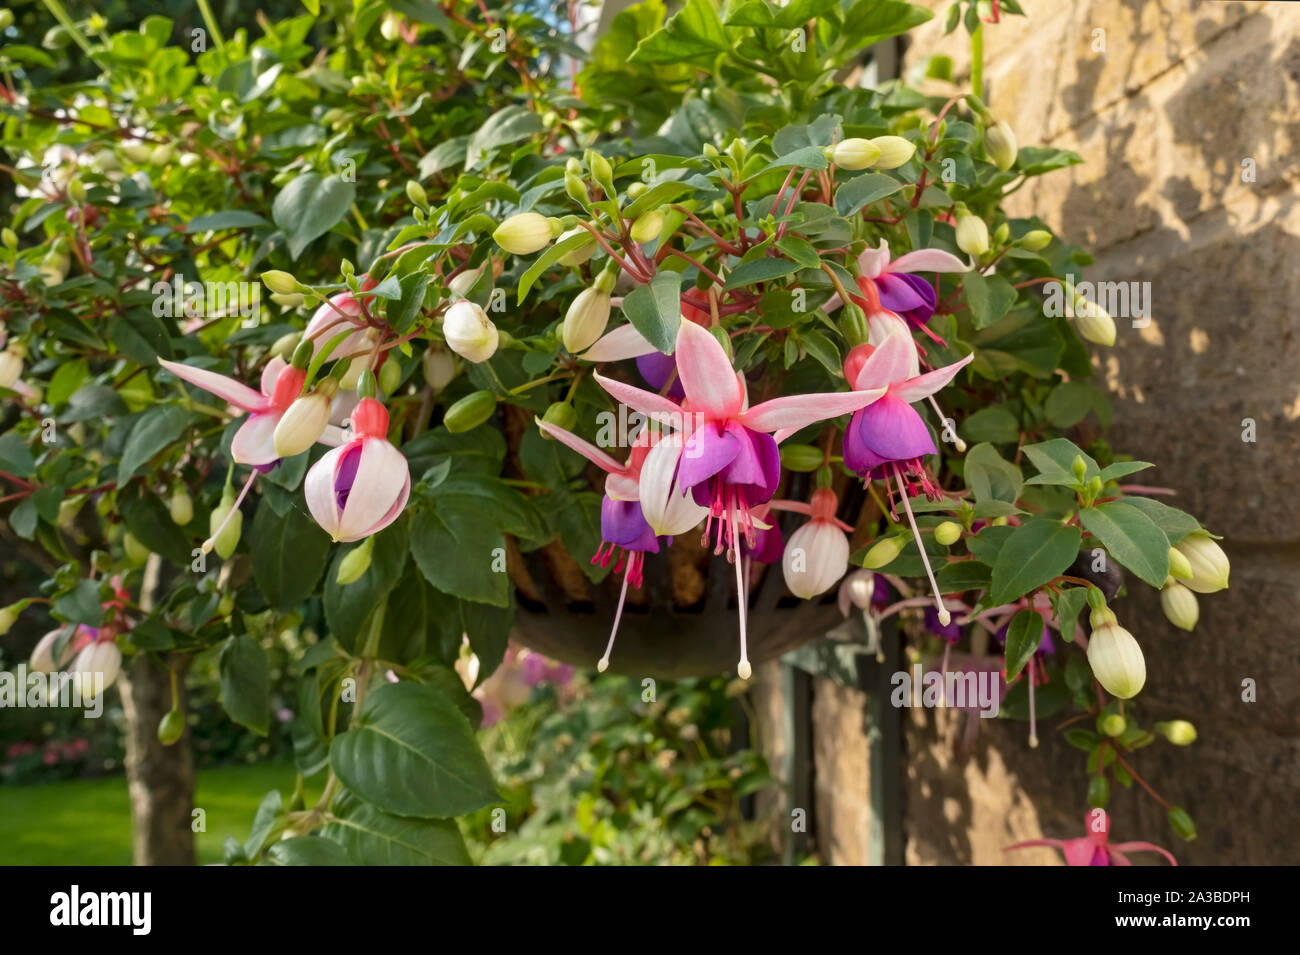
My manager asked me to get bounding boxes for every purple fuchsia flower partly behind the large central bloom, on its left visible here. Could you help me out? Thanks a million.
[537,409,706,673]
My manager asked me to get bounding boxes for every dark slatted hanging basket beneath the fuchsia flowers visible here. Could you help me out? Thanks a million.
[511,474,865,680]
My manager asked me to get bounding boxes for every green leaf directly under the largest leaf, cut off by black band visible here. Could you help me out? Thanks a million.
[321,793,471,865]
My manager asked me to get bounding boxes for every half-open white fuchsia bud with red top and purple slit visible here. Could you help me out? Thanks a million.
[303,398,411,541]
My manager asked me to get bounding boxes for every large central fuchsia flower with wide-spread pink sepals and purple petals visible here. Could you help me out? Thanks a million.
[595,321,884,680]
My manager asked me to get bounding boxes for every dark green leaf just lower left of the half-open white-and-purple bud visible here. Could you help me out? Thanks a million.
[248,500,329,611]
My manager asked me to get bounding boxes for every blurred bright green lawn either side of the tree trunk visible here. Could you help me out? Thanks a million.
[0,763,299,865]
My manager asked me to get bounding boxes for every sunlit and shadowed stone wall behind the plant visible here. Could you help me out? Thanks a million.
[754,0,1300,864]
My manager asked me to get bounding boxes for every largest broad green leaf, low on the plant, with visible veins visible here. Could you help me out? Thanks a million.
[330,682,501,819]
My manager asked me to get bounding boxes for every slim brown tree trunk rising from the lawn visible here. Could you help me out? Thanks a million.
[121,654,195,865]
